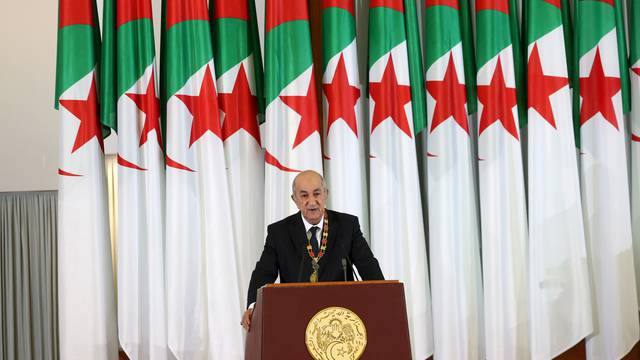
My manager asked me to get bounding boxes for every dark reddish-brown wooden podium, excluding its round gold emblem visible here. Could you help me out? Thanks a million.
[245,281,411,360]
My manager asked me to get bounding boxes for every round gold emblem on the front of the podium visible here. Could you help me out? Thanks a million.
[304,306,367,360]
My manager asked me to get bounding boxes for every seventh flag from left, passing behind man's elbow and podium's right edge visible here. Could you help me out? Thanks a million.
[369,0,433,359]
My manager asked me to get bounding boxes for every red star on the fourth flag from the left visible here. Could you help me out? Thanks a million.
[218,64,260,144]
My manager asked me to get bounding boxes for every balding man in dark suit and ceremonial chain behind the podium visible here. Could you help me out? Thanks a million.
[241,170,384,330]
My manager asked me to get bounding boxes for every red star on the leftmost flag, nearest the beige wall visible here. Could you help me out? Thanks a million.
[60,75,104,154]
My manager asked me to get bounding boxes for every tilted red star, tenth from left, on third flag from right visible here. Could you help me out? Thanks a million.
[527,43,569,129]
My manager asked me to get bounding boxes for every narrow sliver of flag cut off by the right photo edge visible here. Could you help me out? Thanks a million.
[628,0,640,310]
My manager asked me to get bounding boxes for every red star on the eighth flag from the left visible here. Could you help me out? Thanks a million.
[427,52,469,134]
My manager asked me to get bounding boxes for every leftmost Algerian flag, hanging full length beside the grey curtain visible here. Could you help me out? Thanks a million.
[56,0,118,360]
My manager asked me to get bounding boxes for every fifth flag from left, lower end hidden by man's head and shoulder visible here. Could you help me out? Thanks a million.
[260,0,322,225]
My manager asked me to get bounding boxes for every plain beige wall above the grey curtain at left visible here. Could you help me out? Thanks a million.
[0,0,58,191]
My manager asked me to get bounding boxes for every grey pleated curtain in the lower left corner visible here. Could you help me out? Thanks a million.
[0,191,59,360]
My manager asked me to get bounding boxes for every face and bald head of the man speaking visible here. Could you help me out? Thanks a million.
[292,173,327,225]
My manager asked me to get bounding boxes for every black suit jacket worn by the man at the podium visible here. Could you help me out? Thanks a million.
[247,210,384,306]
